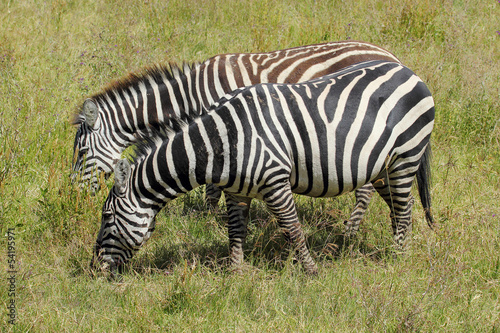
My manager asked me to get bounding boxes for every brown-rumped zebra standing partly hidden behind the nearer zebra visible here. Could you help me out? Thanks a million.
[71,41,399,234]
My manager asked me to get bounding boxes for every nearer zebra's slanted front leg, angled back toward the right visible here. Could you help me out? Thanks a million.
[264,182,318,275]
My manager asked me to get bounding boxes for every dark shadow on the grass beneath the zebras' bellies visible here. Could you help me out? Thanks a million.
[130,211,395,273]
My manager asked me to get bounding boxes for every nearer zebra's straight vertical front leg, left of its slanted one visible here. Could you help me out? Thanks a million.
[226,194,252,272]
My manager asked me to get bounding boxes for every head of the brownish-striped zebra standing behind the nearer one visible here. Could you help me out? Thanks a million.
[70,99,121,193]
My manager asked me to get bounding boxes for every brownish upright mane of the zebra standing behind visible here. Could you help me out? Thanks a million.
[70,62,199,125]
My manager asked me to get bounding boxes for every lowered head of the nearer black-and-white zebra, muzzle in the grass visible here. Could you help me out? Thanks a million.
[90,159,158,273]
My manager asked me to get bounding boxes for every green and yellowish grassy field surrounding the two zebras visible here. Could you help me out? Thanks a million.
[0,0,500,332]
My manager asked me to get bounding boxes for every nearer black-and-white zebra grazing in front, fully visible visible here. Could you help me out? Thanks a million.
[92,61,434,274]
